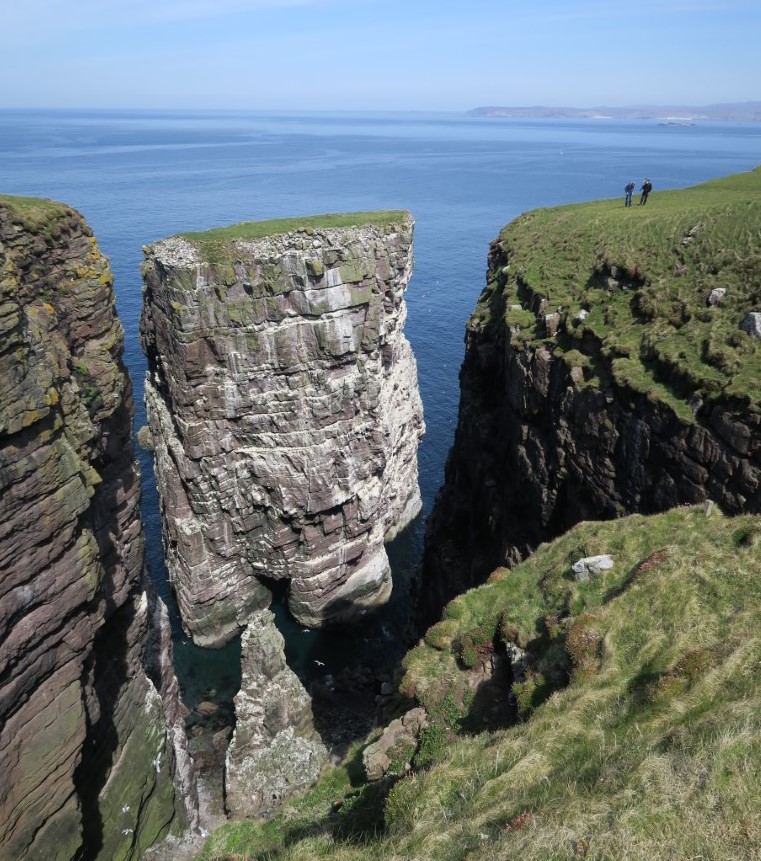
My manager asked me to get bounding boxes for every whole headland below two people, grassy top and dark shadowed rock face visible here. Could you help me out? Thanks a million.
[421,171,761,621]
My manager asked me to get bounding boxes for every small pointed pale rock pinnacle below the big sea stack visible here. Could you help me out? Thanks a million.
[225,610,328,816]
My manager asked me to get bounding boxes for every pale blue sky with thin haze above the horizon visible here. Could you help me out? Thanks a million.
[0,0,761,111]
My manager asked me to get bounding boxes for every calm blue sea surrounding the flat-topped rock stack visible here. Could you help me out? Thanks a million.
[0,110,761,708]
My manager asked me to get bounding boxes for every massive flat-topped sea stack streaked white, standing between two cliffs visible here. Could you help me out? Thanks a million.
[141,212,424,645]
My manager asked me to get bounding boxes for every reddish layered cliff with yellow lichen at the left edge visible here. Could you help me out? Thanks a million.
[0,197,194,861]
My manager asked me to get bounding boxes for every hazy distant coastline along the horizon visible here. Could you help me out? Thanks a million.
[467,102,761,124]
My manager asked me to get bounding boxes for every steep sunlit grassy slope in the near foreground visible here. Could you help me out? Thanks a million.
[194,507,761,861]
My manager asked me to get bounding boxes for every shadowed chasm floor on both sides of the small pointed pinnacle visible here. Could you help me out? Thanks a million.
[148,517,424,826]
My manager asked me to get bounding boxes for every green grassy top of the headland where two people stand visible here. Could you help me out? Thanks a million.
[470,169,761,419]
